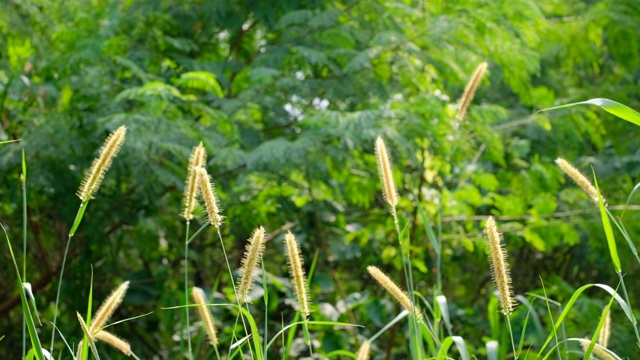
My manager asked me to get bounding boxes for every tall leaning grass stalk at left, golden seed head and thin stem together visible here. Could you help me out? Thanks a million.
[49,125,127,353]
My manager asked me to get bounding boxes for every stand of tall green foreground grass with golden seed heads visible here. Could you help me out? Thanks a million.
[5,97,640,360]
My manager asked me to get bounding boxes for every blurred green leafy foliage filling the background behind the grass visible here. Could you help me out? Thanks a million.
[0,0,640,359]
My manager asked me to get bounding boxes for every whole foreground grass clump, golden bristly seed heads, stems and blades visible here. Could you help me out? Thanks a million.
[3,102,640,360]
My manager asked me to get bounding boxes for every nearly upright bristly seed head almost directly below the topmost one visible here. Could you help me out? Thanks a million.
[485,217,516,315]
